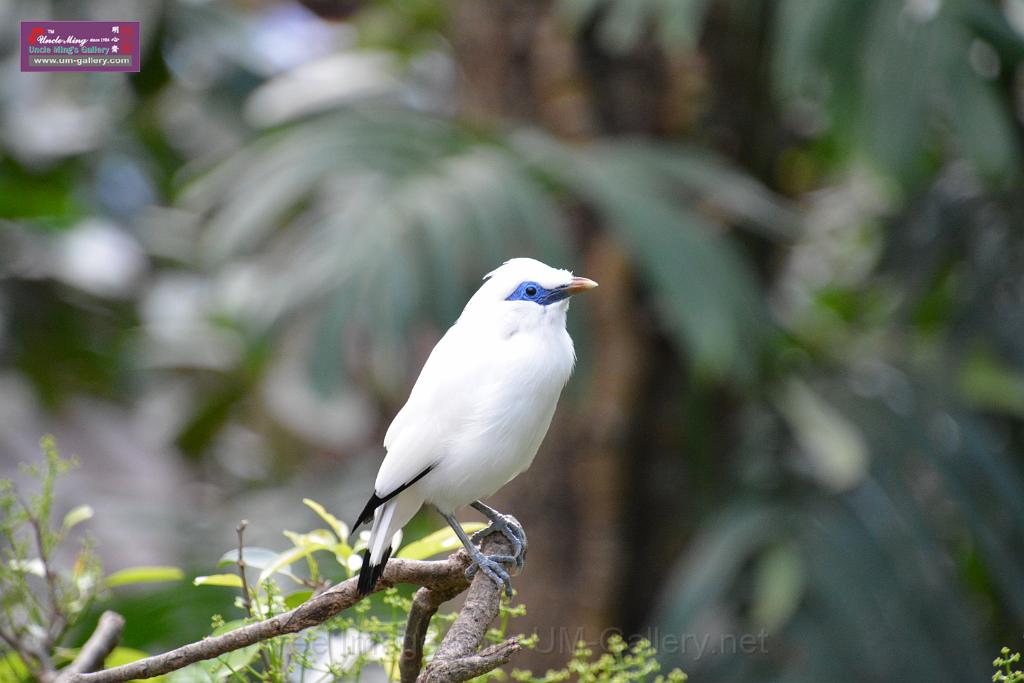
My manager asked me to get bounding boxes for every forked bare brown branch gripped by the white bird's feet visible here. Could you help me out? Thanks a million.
[59,532,519,683]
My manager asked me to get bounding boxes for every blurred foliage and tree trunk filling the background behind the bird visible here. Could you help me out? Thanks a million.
[0,0,1024,683]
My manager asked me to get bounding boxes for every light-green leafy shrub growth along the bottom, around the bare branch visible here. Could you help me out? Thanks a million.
[0,437,688,683]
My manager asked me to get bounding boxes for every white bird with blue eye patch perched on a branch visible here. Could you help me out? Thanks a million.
[353,258,597,595]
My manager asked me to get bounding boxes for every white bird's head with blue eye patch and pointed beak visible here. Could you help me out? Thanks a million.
[464,258,597,325]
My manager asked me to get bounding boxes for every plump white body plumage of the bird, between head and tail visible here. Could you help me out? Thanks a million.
[378,304,575,512]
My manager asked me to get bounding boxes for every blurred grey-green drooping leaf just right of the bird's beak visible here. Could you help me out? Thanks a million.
[561,144,770,380]
